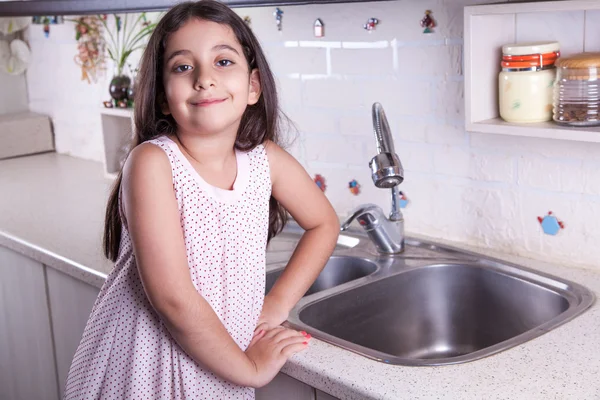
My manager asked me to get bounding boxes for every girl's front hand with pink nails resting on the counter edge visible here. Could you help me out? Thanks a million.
[246,327,310,388]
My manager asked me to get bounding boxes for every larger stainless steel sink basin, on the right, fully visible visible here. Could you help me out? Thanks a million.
[288,263,593,365]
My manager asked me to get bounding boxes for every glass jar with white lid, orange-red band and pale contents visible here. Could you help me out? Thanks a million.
[498,42,560,123]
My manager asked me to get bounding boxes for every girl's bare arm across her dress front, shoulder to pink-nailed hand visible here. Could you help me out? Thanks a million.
[122,144,305,387]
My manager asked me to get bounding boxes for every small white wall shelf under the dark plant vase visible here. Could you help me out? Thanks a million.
[100,107,134,179]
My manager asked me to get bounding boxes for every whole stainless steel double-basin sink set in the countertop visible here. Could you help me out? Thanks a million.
[266,224,594,366]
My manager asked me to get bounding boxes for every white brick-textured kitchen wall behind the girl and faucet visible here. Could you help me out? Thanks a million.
[22,0,600,268]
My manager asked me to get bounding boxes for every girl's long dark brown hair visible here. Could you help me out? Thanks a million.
[103,0,289,261]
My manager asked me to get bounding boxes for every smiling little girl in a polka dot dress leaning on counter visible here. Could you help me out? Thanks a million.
[65,0,339,399]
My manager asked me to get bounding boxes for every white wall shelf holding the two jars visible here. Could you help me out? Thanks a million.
[464,0,600,143]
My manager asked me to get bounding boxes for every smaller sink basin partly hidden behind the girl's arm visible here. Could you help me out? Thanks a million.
[265,256,377,296]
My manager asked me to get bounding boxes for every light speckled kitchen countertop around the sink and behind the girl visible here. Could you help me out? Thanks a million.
[0,153,600,400]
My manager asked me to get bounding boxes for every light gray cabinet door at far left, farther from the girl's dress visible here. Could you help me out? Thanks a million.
[0,247,59,400]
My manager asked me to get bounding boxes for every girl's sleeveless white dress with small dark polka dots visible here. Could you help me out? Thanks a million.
[64,136,271,400]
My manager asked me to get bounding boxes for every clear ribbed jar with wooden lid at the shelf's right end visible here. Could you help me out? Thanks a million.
[553,53,600,126]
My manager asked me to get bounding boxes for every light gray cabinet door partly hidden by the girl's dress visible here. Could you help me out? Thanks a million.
[46,268,100,395]
